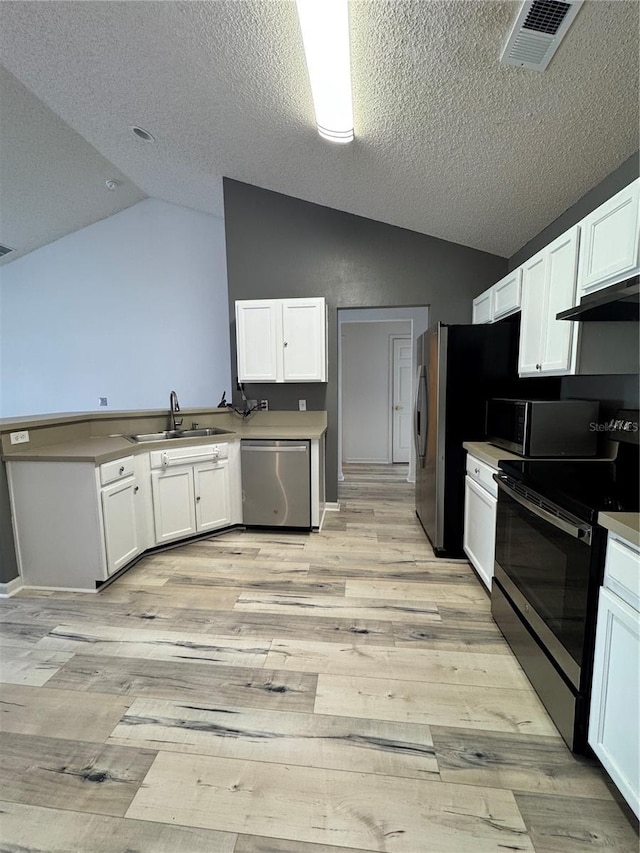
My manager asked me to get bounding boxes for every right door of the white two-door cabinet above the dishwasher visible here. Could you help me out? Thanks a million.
[282,298,327,382]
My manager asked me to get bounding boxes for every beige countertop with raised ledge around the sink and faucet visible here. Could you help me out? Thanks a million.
[0,409,327,465]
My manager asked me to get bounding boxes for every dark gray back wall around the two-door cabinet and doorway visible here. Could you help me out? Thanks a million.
[223,178,507,502]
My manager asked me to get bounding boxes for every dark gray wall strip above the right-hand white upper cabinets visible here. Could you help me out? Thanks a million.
[509,152,640,272]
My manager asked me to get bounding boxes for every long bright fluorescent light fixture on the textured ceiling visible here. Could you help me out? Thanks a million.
[297,0,353,142]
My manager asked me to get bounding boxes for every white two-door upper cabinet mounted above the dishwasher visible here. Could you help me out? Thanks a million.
[236,297,327,382]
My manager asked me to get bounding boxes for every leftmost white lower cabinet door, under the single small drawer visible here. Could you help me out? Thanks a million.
[102,477,140,575]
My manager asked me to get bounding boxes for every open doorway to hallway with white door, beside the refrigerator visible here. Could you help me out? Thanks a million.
[338,306,428,482]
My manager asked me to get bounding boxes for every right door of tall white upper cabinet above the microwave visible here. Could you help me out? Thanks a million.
[539,225,579,375]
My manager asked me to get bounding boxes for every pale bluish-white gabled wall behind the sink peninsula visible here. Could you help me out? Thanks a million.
[0,199,231,417]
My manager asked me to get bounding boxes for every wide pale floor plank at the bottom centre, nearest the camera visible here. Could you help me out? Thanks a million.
[127,753,533,853]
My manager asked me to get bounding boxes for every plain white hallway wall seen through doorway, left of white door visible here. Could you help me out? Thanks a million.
[341,322,411,462]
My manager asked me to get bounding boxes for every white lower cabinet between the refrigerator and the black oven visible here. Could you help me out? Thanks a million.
[463,455,498,590]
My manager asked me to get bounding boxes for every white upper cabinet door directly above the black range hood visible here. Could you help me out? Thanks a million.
[578,179,640,296]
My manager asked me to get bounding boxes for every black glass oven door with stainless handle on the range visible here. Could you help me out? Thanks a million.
[495,474,592,692]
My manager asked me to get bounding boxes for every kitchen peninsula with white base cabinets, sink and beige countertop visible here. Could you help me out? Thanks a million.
[0,408,327,592]
